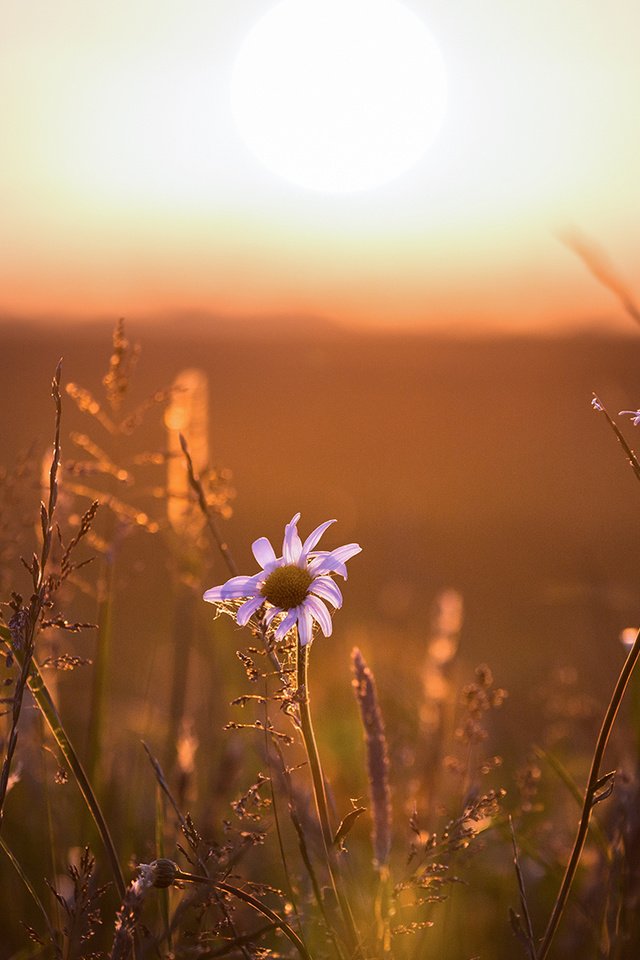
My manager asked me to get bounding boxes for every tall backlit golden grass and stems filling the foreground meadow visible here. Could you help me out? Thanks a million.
[0,323,640,960]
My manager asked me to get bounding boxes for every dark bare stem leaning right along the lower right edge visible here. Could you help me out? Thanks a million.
[537,631,640,960]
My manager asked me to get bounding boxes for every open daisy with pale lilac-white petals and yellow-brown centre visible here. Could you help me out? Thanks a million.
[204,513,362,646]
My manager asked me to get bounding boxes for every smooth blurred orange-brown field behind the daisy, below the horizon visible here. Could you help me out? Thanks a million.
[5,316,640,686]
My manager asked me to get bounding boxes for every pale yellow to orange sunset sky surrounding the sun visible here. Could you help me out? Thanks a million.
[0,0,640,332]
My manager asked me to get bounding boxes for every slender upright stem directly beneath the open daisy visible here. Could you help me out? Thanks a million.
[297,637,362,957]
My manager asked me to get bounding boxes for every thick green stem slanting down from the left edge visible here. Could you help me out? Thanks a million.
[0,626,127,899]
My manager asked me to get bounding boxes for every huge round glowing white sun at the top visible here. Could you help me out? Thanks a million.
[231,0,446,193]
